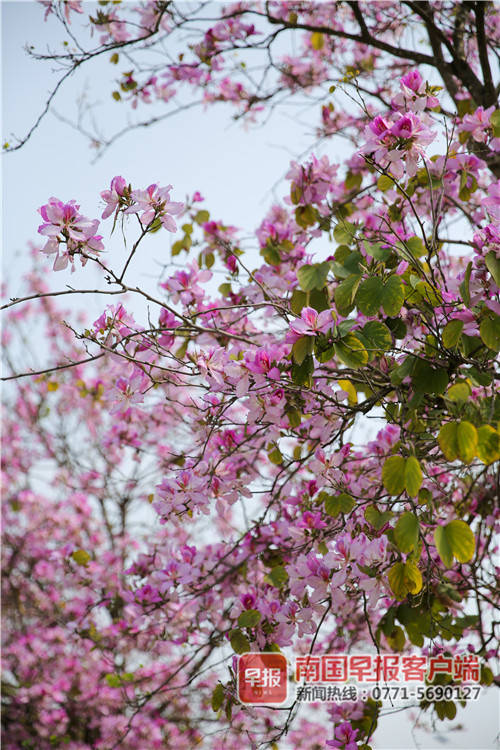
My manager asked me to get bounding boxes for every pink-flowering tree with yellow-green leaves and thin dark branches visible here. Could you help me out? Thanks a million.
[3,0,500,750]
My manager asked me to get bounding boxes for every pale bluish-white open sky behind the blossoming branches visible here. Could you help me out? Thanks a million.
[0,0,499,750]
